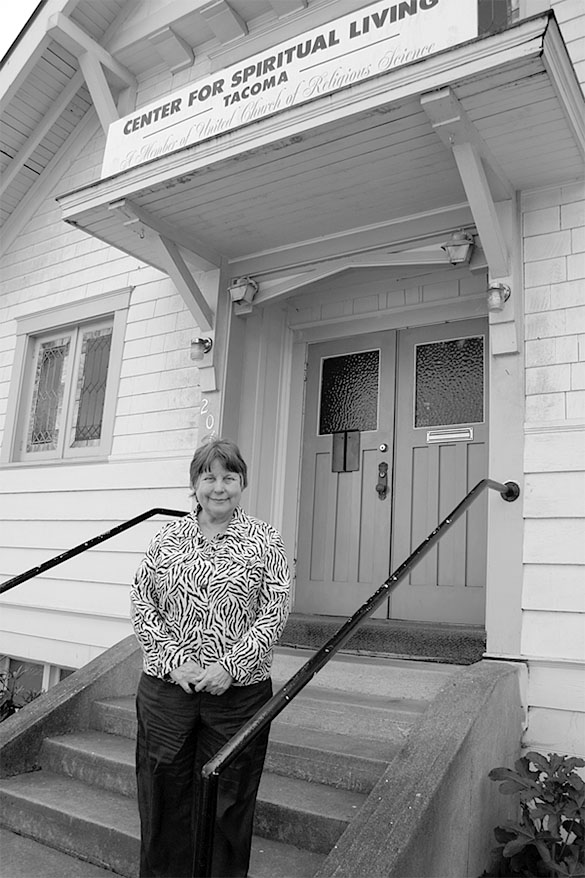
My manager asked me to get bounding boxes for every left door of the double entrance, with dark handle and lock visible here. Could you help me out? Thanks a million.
[295,332,396,617]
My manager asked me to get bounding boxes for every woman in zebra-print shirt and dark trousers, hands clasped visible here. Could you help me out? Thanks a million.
[131,439,290,878]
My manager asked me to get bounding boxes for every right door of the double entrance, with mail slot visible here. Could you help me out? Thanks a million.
[390,320,488,624]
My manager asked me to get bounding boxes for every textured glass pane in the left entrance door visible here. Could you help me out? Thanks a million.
[319,350,380,436]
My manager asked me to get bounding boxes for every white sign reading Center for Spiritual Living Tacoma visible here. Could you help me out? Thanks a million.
[102,0,478,177]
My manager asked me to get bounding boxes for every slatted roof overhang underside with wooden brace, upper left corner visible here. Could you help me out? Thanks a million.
[0,0,133,237]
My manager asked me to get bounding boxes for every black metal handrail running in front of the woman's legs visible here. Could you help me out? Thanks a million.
[193,479,520,878]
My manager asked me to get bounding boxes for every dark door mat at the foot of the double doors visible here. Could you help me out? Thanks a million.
[280,613,486,665]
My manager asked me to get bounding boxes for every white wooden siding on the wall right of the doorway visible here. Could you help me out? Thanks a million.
[521,170,585,756]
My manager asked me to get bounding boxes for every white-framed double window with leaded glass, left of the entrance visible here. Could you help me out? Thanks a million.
[0,287,132,466]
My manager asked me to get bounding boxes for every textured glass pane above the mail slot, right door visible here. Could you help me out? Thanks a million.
[414,335,484,427]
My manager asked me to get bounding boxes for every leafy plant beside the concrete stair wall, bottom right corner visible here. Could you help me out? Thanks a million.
[489,752,585,878]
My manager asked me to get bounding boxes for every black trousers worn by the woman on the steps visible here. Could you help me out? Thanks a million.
[136,674,272,878]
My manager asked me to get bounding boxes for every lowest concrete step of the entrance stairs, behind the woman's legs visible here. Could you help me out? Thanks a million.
[0,771,324,878]
